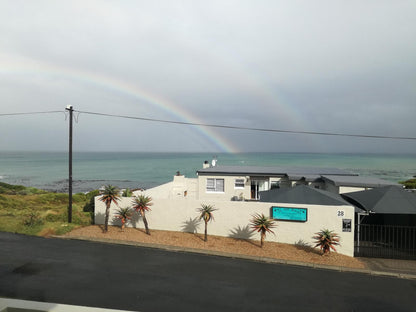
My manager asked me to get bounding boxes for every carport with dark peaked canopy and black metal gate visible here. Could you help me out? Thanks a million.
[342,186,416,259]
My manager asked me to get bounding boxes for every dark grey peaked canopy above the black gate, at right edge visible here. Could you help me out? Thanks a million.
[342,186,416,214]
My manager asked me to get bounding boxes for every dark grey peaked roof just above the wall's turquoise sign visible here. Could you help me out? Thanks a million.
[260,185,351,206]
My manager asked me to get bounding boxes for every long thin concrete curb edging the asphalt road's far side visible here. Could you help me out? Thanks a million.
[51,235,416,280]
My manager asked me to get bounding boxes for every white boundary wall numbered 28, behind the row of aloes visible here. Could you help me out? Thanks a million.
[95,197,354,256]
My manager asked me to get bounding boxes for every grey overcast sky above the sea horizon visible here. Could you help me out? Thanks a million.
[0,0,416,153]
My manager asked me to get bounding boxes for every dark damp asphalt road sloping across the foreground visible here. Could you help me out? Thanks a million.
[0,232,416,312]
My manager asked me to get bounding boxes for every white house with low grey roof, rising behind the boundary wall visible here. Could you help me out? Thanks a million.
[196,164,397,200]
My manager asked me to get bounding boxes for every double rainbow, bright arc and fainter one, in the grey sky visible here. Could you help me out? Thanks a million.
[0,52,322,153]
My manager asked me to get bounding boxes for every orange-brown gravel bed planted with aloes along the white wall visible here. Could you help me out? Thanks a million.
[64,225,366,269]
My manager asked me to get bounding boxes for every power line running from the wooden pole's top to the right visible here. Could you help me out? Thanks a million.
[74,110,416,140]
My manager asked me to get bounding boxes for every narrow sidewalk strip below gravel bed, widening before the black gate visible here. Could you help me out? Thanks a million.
[57,236,416,280]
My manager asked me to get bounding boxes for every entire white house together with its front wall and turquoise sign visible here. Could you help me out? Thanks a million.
[95,161,402,256]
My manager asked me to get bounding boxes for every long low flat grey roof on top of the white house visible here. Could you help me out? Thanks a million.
[197,166,357,176]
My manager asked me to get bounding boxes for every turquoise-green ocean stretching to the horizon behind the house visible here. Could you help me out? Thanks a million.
[0,152,416,193]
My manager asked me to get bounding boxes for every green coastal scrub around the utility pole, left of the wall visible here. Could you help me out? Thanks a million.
[0,182,96,236]
